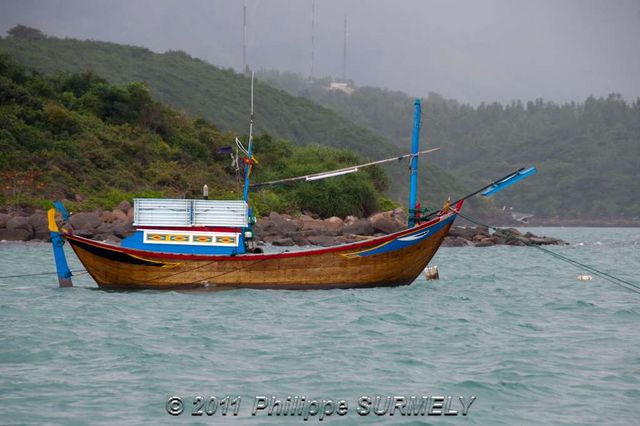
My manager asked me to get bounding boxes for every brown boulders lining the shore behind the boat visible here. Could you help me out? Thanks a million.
[0,205,566,247]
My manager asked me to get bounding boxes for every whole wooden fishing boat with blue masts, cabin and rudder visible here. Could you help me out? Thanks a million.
[49,80,535,290]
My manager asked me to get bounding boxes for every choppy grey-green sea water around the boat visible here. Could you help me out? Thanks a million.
[0,228,640,424]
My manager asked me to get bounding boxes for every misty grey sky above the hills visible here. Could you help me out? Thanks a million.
[0,0,640,104]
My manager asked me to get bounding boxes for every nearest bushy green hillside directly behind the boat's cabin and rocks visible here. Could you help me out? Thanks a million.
[0,55,387,216]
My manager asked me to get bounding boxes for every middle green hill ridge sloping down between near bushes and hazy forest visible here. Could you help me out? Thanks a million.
[0,30,467,211]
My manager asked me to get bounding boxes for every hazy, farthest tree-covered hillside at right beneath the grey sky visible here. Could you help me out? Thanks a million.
[259,71,640,220]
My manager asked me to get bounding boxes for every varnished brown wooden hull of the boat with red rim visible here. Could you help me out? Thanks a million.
[66,213,456,290]
